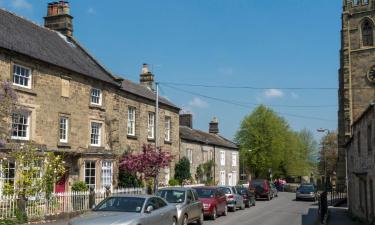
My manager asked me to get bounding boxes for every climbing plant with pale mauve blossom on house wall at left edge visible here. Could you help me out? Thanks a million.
[0,81,17,147]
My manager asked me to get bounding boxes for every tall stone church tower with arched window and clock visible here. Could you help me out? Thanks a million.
[337,0,375,185]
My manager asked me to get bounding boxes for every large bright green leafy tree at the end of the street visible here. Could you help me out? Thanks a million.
[236,105,312,178]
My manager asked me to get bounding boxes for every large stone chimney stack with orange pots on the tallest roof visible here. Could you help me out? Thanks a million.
[44,1,73,37]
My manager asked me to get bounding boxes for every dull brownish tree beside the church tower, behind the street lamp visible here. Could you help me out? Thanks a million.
[319,132,338,176]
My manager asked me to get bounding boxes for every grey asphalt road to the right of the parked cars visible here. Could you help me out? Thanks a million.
[38,193,317,225]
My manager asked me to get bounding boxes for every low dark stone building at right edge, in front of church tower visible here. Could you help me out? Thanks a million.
[347,104,375,223]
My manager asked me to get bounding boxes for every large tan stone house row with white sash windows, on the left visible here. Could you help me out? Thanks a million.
[0,1,179,192]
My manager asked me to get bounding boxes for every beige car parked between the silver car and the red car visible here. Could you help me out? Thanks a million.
[156,187,204,225]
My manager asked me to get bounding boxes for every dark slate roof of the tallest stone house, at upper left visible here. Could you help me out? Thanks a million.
[0,9,119,85]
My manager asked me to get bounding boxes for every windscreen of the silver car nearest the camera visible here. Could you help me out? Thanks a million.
[94,197,145,213]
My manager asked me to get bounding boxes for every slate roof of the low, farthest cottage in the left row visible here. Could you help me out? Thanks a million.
[180,126,238,150]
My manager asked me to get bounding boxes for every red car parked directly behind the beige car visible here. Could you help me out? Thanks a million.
[194,187,228,220]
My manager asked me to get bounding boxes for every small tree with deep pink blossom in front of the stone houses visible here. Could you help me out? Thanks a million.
[120,145,173,191]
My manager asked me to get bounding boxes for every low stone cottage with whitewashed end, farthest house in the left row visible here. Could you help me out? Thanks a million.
[180,114,239,185]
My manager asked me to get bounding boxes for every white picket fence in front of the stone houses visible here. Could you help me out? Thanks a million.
[0,188,145,219]
